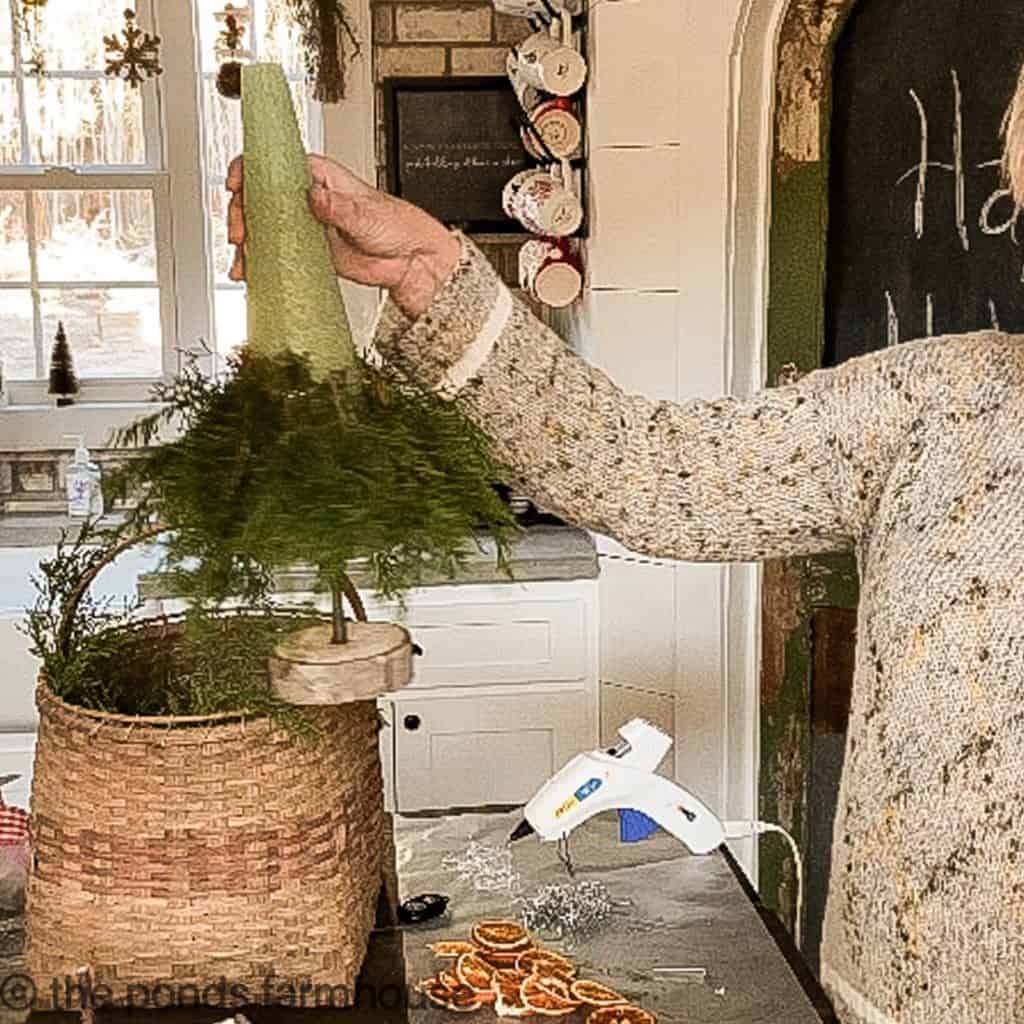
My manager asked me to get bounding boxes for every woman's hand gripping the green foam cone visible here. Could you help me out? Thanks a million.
[226,156,460,318]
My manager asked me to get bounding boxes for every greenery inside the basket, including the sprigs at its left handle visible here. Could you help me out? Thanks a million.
[25,522,317,737]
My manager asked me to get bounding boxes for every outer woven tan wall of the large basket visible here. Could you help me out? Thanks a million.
[27,659,387,1005]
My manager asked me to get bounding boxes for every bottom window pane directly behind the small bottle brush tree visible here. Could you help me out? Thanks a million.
[40,288,162,378]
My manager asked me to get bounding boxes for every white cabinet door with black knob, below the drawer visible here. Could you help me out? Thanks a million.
[392,691,595,813]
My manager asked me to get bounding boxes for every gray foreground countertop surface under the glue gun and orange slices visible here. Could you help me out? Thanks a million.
[0,813,833,1024]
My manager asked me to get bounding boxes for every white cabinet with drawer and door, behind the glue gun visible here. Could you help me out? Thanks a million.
[368,580,599,813]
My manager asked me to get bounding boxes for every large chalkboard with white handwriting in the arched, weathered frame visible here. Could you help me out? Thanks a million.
[824,0,1024,365]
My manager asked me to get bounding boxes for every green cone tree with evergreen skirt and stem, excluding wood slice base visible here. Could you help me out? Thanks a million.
[121,65,517,643]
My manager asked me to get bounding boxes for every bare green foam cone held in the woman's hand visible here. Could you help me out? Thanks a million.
[242,63,356,380]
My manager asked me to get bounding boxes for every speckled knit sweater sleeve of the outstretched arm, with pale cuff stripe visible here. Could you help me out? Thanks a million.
[374,239,942,561]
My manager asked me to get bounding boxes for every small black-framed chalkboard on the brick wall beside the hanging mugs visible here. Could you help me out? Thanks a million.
[384,78,530,233]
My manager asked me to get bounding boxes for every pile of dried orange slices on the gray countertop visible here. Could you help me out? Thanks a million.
[419,921,656,1024]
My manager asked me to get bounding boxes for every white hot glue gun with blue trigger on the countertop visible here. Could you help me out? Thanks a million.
[511,718,726,854]
